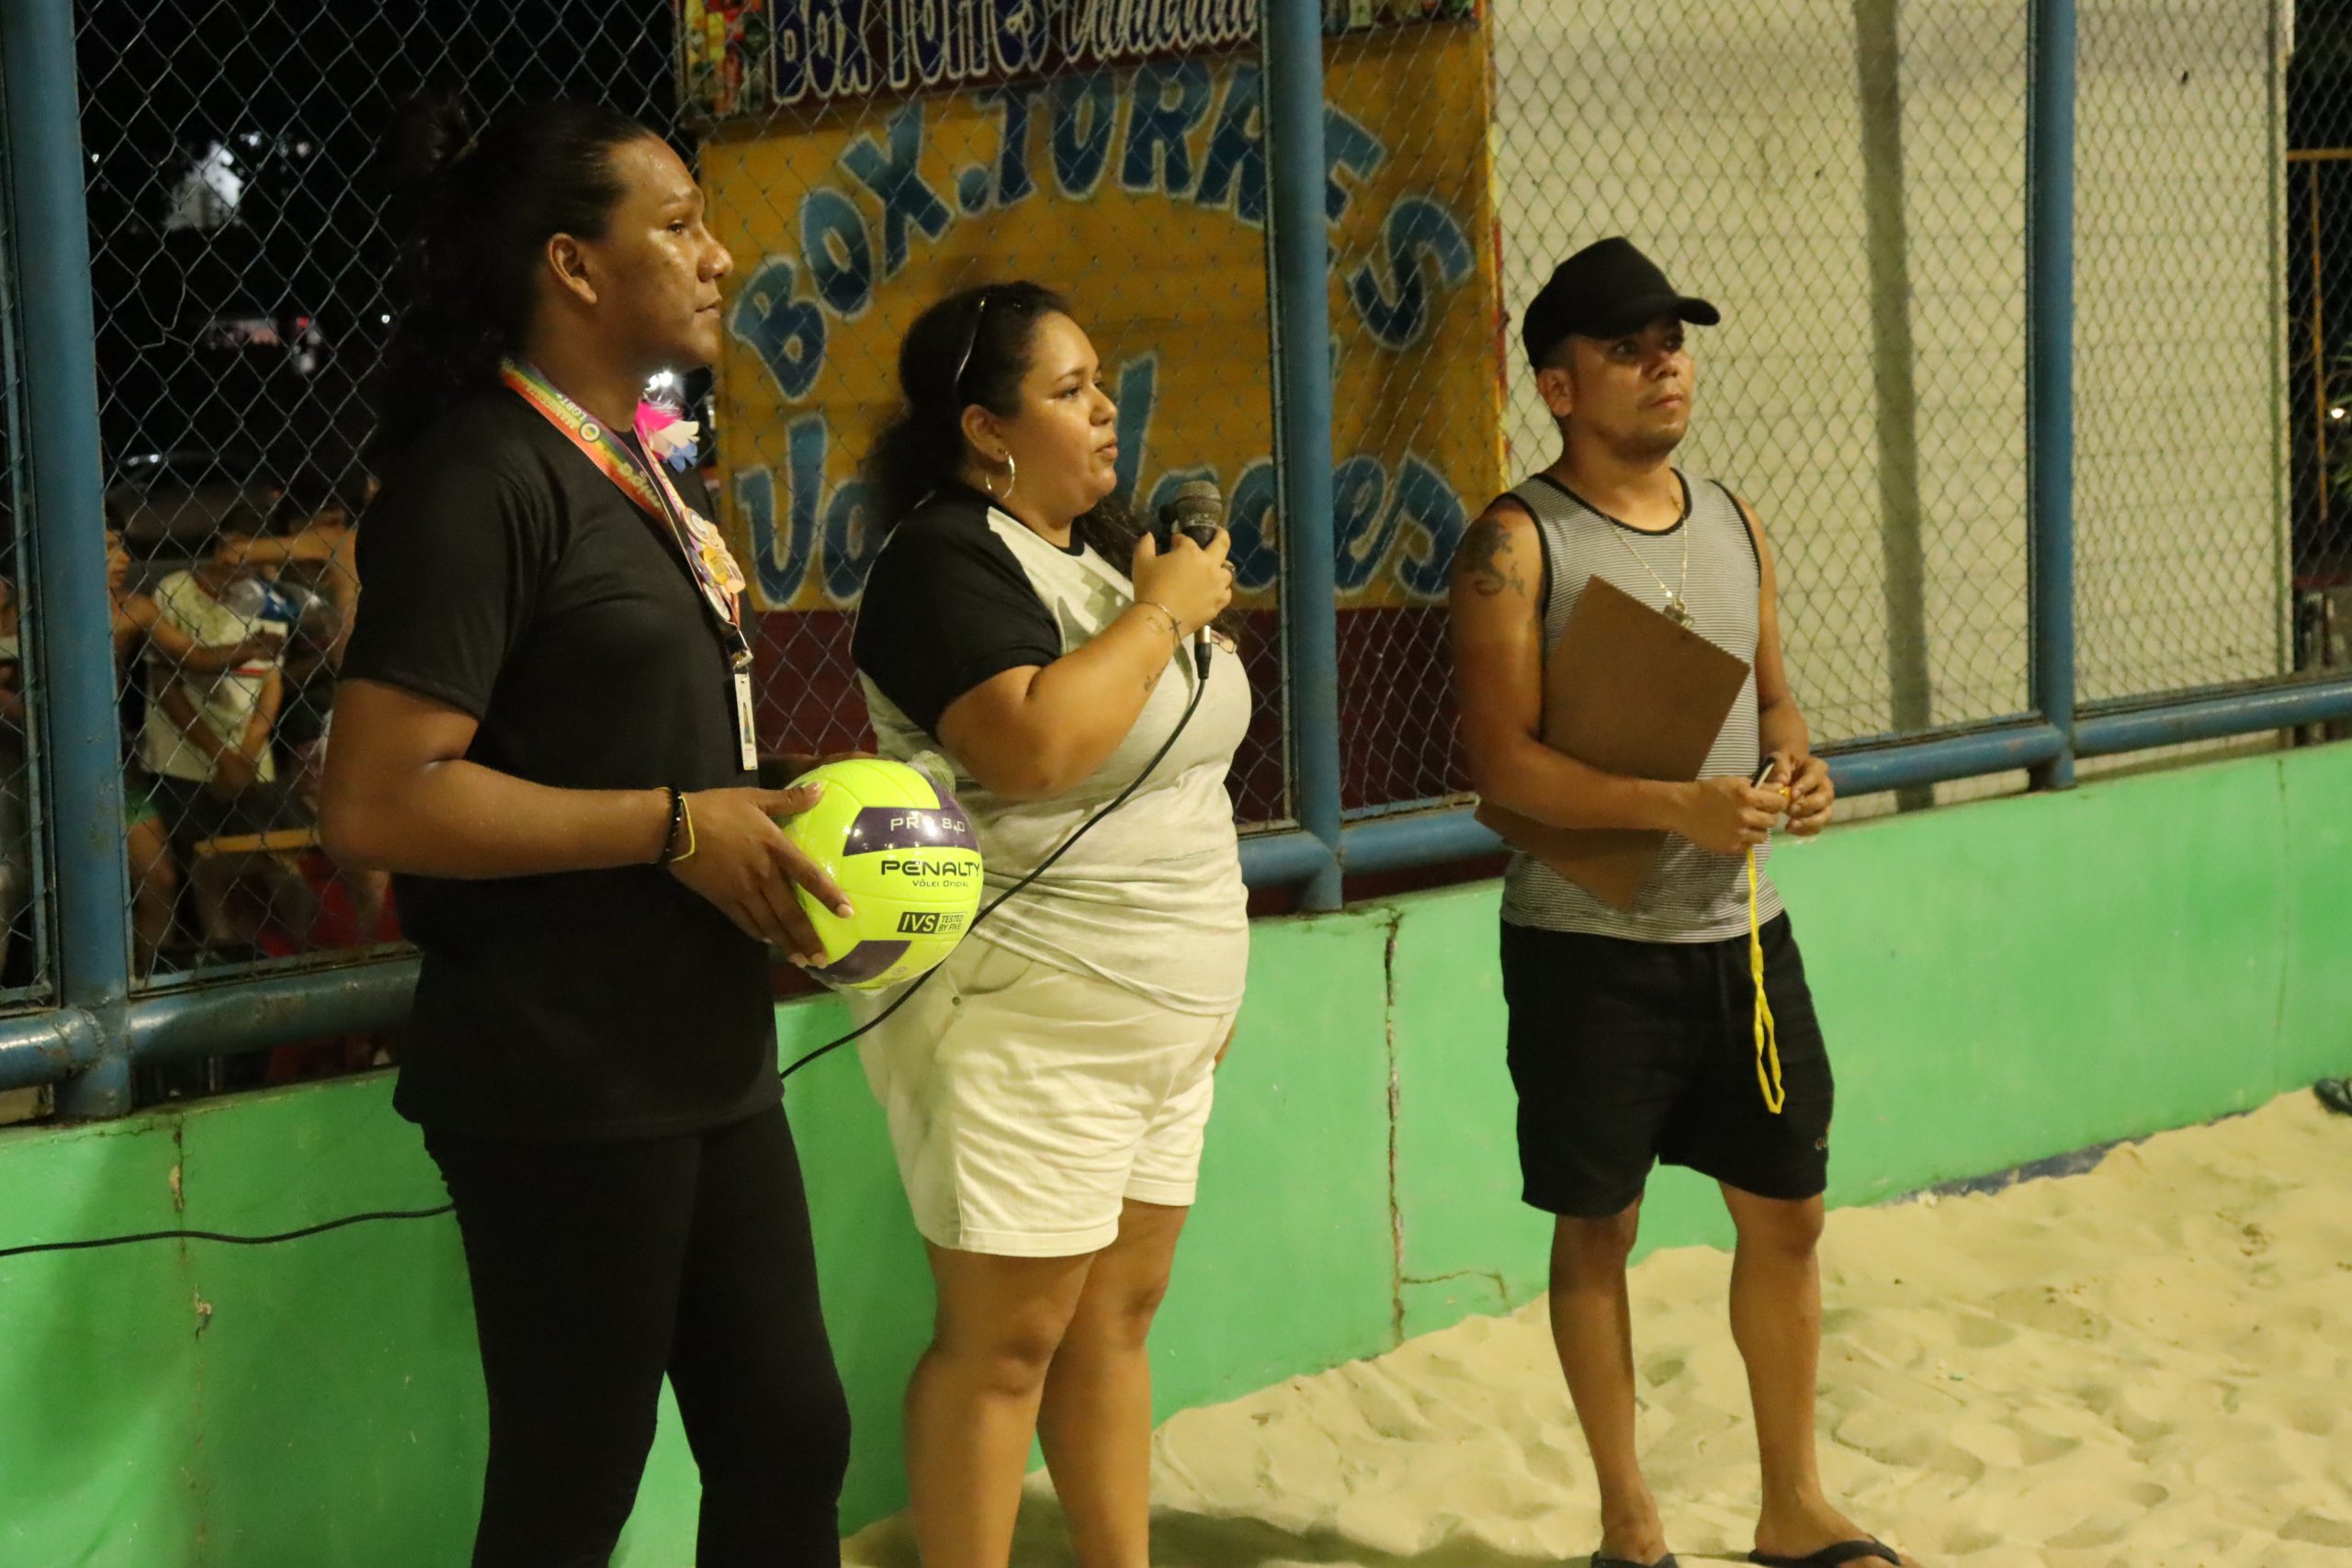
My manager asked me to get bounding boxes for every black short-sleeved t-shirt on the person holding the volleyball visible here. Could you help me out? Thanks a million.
[344,390,781,1140]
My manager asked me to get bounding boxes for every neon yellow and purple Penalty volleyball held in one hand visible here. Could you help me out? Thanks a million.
[781,757,981,989]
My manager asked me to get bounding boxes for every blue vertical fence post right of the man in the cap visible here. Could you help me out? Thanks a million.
[2025,0,2075,790]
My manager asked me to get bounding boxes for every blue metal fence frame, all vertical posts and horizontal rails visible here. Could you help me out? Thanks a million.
[0,0,2352,1114]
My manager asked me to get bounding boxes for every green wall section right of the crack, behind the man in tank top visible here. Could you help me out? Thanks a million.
[1393,745,2352,1333]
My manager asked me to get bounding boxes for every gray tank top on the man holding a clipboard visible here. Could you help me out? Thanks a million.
[1503,472,1781,942]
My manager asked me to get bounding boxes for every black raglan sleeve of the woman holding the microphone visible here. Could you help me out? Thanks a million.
[849,484,1063,739]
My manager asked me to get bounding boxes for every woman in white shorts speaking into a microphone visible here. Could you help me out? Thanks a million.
[852,282,1249,1568]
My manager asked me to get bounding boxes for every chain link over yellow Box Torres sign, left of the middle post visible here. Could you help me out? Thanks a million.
[684,17,1294,828]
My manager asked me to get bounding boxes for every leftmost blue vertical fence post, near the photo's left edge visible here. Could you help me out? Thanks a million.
[0,0,131,1117]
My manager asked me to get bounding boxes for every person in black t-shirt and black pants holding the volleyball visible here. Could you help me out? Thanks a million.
[322,101,849,1568]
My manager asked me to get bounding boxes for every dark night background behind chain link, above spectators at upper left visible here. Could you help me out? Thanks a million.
[77,0,675,501]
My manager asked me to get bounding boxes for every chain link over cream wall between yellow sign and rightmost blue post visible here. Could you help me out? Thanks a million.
[1494,0,2028,761]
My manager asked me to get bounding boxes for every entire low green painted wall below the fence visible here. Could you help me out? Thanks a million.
[0,748,2352,1568]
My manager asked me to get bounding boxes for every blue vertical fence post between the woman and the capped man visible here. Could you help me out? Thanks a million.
[1263,0,1340,909]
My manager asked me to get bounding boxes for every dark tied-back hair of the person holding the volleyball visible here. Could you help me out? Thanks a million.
[369,92,654,472]
